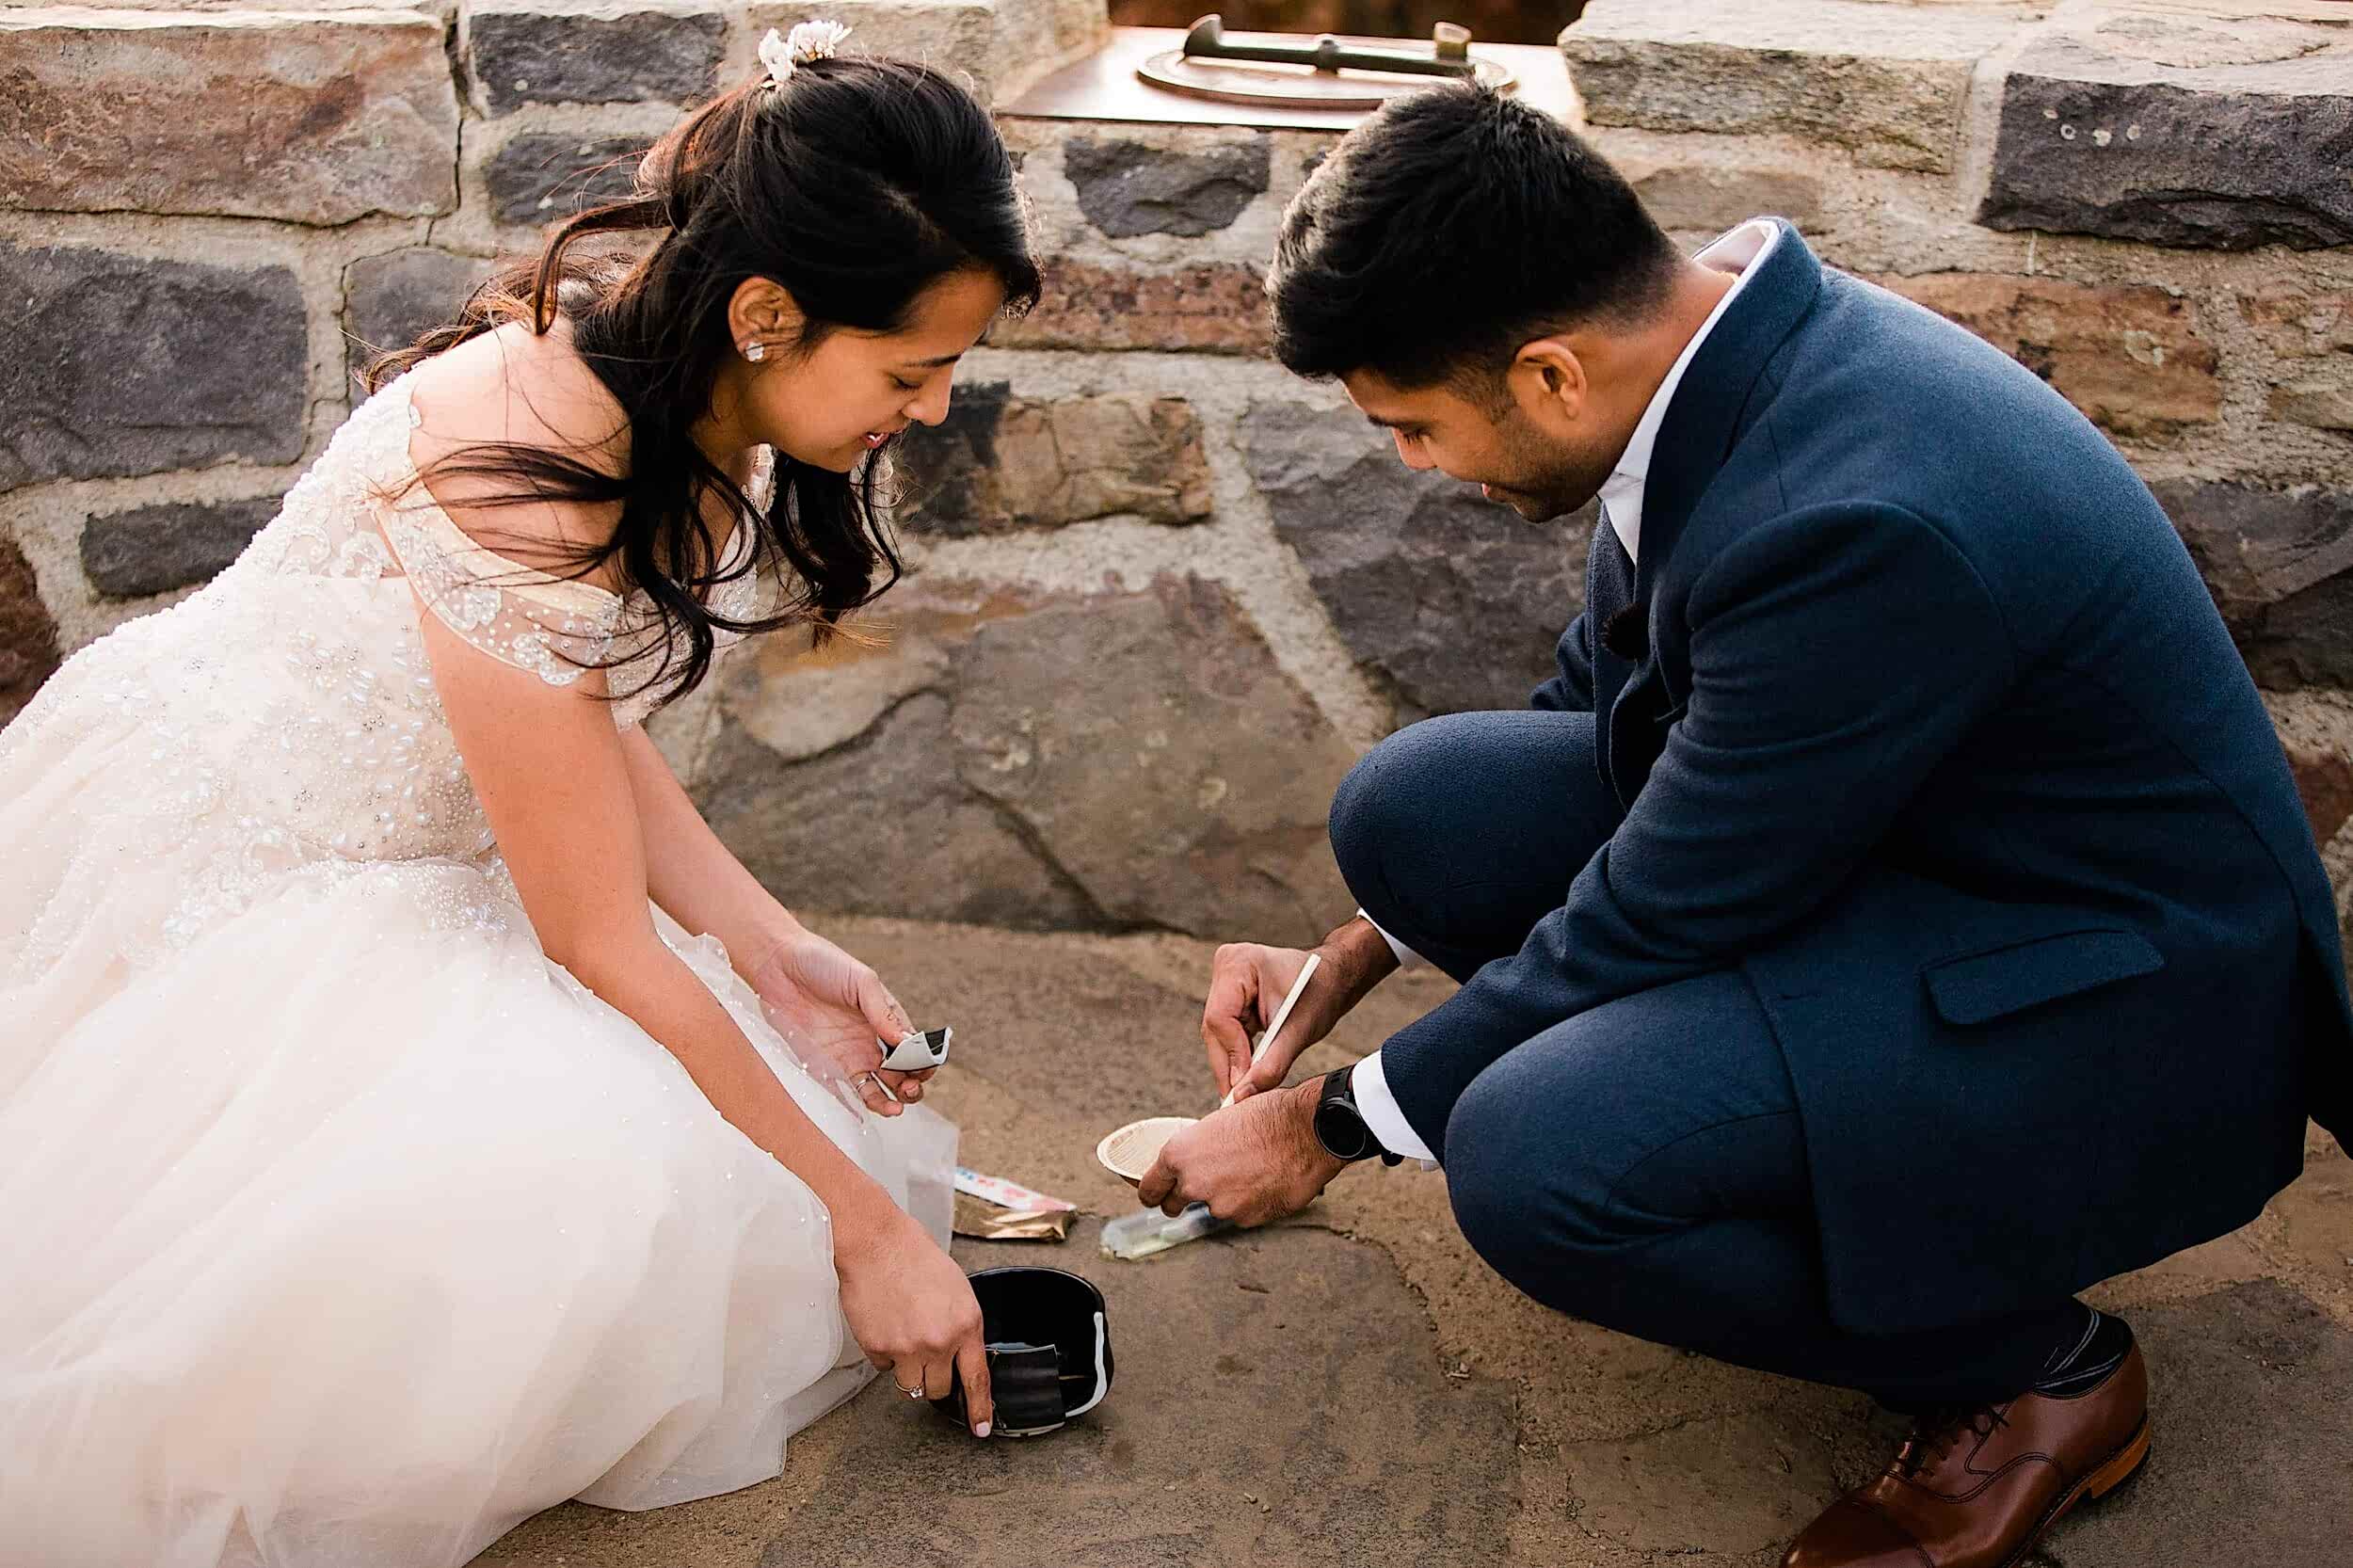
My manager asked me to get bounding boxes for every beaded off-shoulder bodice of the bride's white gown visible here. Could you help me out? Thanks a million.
[0,379,772,968]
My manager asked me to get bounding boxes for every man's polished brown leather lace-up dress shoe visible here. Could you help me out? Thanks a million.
[1782,1344,2149,1568]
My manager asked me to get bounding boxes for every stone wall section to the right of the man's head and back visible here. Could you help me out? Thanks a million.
[1562,0,2353,941]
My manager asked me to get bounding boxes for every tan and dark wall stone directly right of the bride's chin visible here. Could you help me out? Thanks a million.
[902,381,1209,536]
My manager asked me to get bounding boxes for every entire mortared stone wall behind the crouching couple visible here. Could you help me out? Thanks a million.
[0,0,2353,937]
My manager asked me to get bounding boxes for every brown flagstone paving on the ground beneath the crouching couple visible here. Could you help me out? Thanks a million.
[480,920,2353,1568]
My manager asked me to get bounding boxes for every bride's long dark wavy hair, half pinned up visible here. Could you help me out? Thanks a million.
[367,56,1038,699]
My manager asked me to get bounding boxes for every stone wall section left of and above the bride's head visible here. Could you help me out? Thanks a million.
[0,0,1109,715]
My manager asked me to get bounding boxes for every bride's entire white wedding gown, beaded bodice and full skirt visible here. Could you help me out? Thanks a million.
[0,379,955,1568]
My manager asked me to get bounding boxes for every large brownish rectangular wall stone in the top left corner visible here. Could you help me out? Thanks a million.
[0,8,456,224]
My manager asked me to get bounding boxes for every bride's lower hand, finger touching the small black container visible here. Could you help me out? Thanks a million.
[833,1208,996,1436]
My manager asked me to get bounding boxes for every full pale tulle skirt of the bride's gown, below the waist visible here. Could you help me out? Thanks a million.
[0,645,955,1568]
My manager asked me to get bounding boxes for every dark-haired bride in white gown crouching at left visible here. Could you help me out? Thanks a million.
[0,24,1038,1568]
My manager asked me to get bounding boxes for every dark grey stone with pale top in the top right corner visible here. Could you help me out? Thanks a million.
[1977,14,2353,249]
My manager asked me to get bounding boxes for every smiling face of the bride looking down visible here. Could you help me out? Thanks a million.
[715,271,1005,473]
